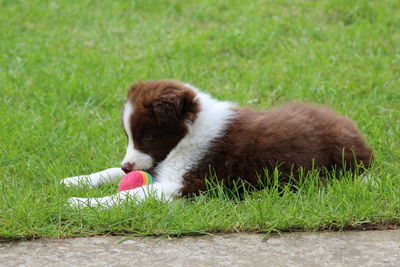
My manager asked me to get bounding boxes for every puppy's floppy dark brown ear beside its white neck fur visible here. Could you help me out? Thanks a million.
[151,88,197,124]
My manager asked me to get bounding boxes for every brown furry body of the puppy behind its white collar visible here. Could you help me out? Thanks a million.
[182,103,373,194]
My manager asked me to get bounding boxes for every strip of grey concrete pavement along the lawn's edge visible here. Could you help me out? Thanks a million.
[0,230,400,266]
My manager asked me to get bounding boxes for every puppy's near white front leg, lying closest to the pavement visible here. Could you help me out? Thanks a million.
[68,182,182,208]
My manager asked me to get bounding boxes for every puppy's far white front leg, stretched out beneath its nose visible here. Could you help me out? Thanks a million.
[60,168,125,187]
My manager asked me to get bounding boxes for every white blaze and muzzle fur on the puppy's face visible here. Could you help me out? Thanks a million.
[122,101,153,170]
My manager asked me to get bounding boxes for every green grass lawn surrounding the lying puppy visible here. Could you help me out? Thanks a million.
[0,0,400,240]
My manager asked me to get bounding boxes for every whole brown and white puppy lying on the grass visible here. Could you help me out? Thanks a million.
[62,80,373,206]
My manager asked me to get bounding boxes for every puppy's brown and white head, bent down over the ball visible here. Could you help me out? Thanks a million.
[121,80,200,173]
